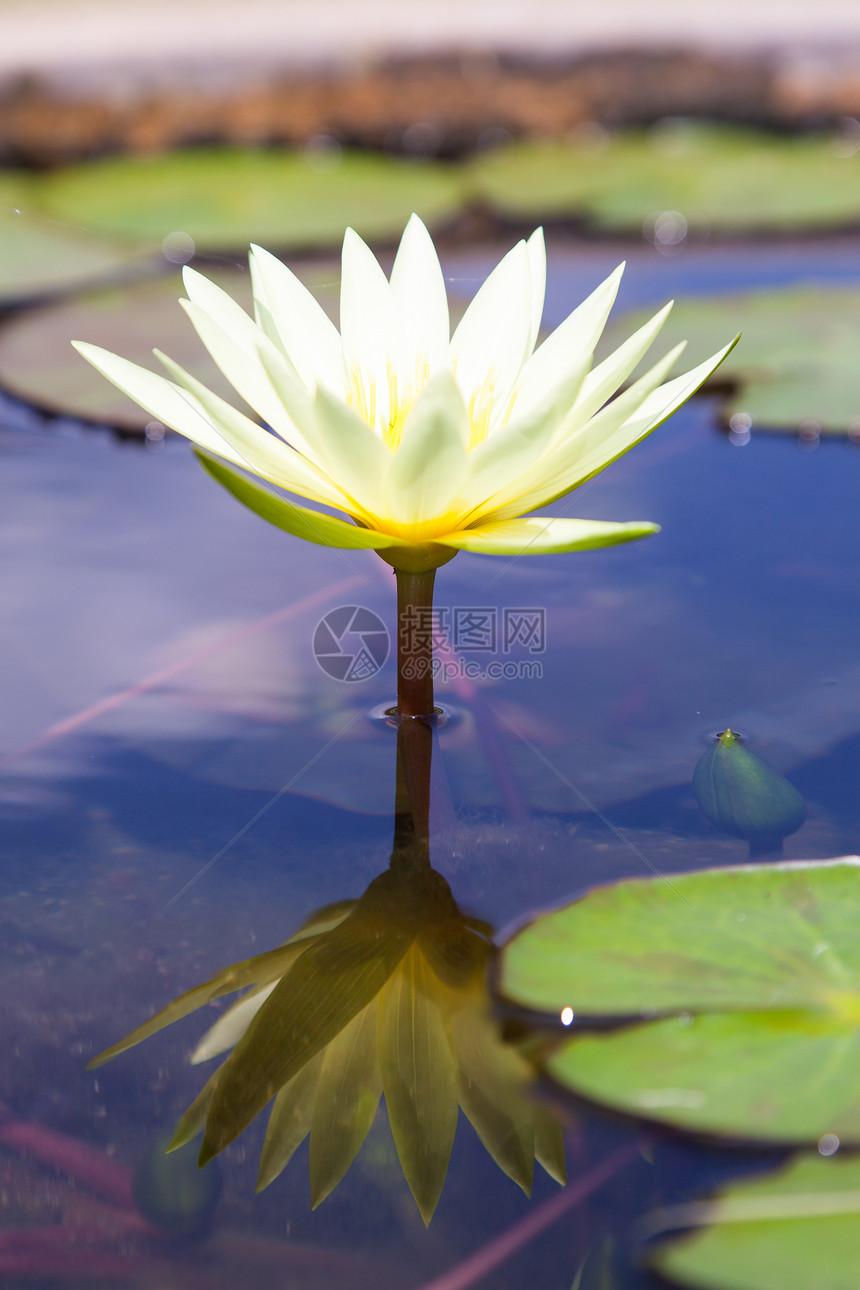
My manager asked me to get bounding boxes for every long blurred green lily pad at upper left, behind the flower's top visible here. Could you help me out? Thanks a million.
[33,148,460,253]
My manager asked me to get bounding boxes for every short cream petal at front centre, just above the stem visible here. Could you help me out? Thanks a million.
[386,373,468,524]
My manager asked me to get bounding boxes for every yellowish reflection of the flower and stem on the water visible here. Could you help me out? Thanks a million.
[93,720,565,1222]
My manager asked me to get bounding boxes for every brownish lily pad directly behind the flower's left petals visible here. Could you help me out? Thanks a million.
[0,256,340,433]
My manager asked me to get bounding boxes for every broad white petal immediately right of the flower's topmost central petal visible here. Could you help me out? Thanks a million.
[449,234,533,437]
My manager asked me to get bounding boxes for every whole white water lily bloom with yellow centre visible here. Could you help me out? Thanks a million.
[76,215,734,571]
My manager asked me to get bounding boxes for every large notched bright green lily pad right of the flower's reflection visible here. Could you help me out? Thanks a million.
[500,858,860,1142]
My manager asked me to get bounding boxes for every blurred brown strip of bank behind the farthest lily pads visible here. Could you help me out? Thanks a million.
[0,50,860,166]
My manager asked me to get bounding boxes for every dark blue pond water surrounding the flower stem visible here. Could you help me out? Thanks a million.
[0,240,860,1290]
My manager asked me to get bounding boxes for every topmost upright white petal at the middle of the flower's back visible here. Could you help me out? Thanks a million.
[391,215,450,379]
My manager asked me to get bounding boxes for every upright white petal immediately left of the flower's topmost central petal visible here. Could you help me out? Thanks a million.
[340,228,397,432]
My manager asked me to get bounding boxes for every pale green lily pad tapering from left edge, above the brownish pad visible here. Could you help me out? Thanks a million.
[0,173,152,306]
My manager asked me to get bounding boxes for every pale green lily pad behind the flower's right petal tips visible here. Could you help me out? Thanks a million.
[606,286,860,435]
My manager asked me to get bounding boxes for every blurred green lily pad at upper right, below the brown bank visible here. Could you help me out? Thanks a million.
[471,123,860,232]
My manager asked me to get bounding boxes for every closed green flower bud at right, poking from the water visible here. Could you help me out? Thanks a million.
[692,730,806,842]
